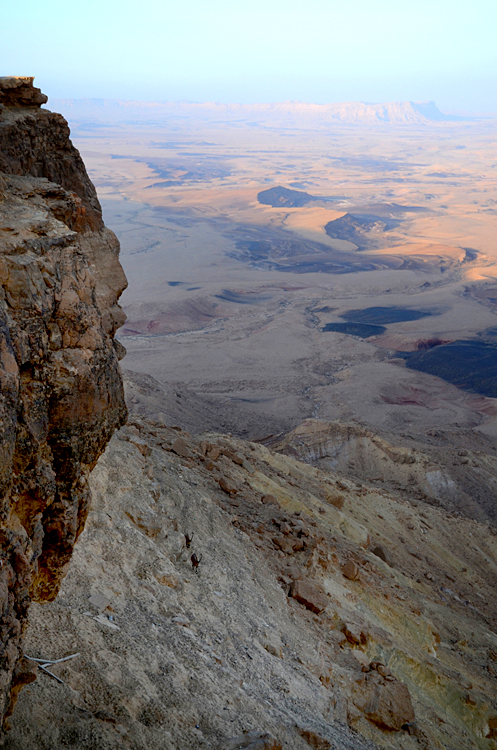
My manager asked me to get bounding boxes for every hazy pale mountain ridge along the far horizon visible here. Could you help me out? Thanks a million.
[49,99,475,126]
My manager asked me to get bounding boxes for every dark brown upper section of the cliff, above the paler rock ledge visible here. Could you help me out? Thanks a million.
[0,76,103,230]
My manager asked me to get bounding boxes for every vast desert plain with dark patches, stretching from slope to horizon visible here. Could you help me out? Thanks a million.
[51,102,497,446]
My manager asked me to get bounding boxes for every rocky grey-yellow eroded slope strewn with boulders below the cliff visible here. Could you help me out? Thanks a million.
[7,417,497,750]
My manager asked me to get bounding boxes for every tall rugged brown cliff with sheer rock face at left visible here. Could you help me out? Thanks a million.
[0,77,126,721]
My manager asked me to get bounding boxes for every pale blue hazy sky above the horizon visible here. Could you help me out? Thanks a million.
[0,0,497,112]
